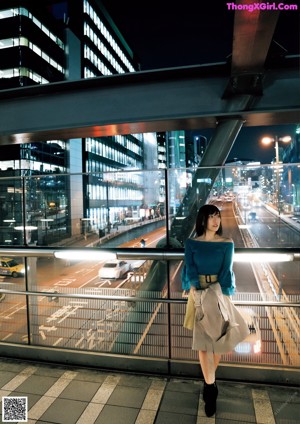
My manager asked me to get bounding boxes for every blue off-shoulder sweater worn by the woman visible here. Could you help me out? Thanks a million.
[182,239,235,296]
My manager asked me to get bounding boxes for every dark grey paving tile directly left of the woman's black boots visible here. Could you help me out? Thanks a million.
[160,390,199,416]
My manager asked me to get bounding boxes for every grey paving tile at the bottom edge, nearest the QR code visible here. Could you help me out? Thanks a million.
[38,398,88,424]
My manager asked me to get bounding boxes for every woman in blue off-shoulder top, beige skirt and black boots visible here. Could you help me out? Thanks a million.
[183,205,249,417]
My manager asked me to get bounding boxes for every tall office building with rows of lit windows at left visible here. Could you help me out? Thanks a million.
[0,0,152,244]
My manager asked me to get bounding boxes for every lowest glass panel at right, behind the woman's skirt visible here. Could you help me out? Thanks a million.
[170,293,300,366]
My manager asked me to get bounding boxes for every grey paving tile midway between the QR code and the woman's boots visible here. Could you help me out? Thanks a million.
[107,385,147,408]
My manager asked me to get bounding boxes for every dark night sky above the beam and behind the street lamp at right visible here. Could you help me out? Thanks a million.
[102,0,300,163]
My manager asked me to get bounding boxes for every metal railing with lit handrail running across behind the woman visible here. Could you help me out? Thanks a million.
[0,247,300,384]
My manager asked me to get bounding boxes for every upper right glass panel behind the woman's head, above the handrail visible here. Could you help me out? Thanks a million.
[169,163,300,247]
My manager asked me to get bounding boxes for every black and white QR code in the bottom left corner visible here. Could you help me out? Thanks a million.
[2,396,28,423]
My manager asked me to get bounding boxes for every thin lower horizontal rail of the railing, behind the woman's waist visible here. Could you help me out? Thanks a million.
[0,289,300,308]
